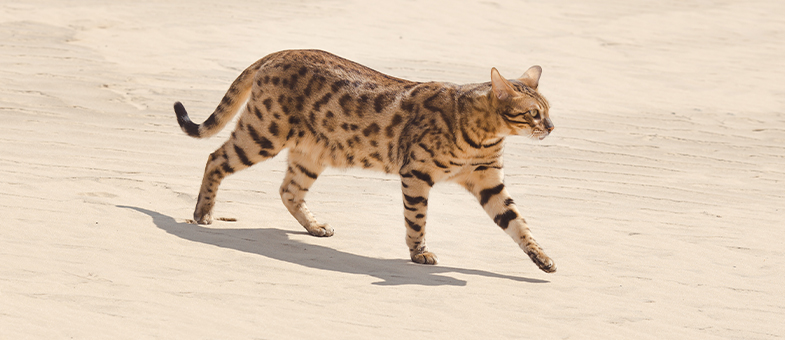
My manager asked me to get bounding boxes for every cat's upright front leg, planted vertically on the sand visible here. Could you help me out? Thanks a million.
[400,169,439,264]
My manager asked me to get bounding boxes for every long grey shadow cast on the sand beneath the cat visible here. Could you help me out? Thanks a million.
[117,205,549,286]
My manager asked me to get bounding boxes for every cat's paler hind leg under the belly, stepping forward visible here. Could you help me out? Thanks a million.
[280,150,335,237]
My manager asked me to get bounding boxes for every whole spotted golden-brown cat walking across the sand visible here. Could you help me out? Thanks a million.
[174,50,556,273]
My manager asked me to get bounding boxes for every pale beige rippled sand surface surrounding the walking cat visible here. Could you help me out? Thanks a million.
[0,0,785,339]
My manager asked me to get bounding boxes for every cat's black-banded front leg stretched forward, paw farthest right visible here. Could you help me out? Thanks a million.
[464,169,556,273]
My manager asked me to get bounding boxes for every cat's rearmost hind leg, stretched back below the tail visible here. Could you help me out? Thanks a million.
[194,119,283,224]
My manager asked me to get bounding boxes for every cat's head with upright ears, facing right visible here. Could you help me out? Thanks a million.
[491,66,553,140]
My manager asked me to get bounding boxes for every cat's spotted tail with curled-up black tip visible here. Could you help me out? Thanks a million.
[174,58,266,138]
